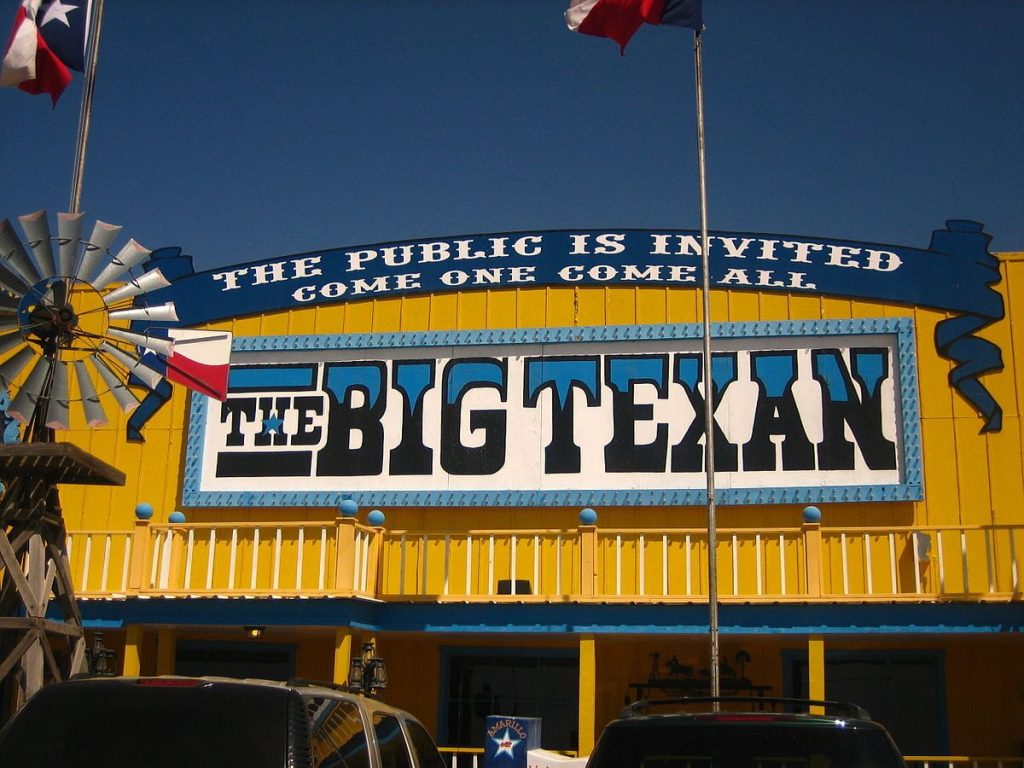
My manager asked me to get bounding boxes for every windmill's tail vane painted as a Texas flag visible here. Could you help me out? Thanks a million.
[142,328,231,400]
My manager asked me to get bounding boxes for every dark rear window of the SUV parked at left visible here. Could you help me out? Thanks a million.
[0,682,289,768]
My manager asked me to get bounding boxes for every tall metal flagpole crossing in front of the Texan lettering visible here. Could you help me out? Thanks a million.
[693,30,721,696]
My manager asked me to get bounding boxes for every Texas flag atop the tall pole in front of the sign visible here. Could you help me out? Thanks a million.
[565,0,703,53]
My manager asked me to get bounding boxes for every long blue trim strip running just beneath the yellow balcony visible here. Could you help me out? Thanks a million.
[68,598,1024,636]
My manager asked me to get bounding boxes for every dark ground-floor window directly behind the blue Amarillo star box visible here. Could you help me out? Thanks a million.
[439,648,580,750]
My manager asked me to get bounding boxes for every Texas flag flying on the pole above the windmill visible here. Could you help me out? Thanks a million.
[0,0,92,104]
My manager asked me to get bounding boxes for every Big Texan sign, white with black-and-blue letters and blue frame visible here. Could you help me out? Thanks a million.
[185,319,922,506]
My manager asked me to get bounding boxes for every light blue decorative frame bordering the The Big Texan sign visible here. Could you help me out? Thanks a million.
[181,317,924,507]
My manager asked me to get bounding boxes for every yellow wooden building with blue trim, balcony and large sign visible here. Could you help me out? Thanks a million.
[24,227,1024,764]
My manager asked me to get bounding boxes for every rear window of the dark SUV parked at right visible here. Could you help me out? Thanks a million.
[588,719,904,768]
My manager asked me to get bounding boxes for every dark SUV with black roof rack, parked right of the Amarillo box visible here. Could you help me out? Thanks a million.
[587,697,906,768]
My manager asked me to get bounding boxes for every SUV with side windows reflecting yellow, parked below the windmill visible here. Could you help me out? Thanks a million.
[0,677,444,768]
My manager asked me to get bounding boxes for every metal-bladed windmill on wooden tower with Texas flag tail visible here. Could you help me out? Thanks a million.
[0,211,230,711]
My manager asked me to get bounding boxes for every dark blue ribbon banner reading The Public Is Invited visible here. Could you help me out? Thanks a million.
[129,219,1006,439]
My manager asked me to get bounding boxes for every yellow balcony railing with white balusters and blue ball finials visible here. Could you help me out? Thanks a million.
[68,517,1024,602]
